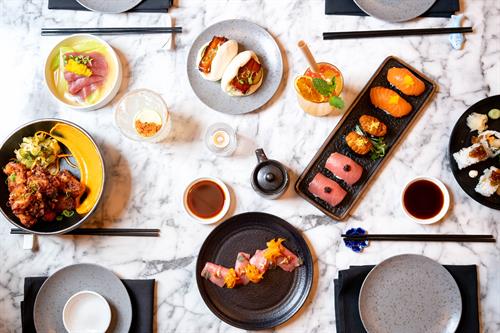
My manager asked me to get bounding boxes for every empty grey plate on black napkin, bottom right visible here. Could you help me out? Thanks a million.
[359,254,462,333]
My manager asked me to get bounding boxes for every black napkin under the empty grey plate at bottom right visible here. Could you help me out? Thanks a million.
[333,265,479,333]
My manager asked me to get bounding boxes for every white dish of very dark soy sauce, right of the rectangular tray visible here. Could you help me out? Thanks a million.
[402,177,450,224]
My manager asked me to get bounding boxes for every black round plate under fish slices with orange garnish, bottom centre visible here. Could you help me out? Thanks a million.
[196,212,313,330]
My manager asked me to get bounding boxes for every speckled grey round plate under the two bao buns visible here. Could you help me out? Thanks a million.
[187,20,283,114]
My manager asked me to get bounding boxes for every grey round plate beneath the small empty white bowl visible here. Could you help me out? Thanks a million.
[33,264,132,333]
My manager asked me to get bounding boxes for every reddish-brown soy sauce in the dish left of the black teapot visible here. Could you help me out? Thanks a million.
[187,180,226,219]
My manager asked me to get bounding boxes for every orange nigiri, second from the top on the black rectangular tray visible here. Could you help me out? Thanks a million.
[370,87,412,118]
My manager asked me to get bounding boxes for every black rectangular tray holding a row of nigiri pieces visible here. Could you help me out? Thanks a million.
[295,56,436,221]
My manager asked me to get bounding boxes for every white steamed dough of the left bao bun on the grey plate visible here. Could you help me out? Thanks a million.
[196,39,238,81]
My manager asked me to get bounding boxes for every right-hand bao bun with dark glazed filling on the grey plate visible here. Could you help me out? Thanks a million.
[221,51,263,96]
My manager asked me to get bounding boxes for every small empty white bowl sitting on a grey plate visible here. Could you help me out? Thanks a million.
[63,290,111,333]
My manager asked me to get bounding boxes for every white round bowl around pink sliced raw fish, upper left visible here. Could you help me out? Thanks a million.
[45,34,123,111]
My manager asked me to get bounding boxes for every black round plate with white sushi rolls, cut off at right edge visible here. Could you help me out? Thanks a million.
[448,95,500,210]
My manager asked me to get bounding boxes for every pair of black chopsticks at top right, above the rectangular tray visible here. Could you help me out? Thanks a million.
[323,27,472,40]
